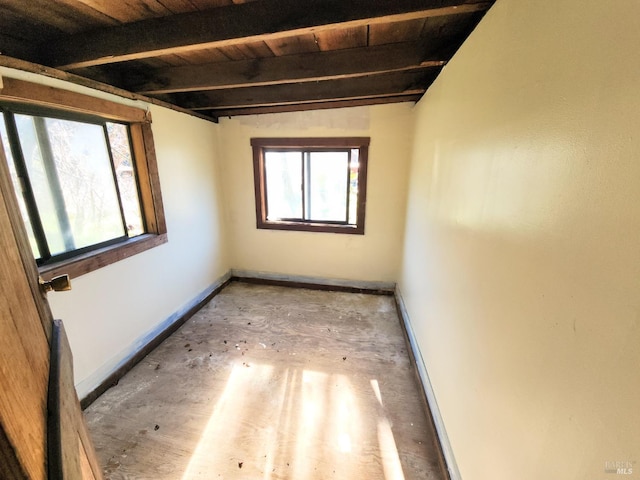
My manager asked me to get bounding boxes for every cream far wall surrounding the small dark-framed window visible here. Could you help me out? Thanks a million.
[219,103,413,282]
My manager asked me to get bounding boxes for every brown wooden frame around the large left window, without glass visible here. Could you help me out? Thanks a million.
[0,77,167,280]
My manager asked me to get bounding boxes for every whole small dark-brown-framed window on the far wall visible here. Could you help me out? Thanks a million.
[251,137,370,235]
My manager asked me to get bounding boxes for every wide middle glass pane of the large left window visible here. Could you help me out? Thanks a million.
[15,115,125,255]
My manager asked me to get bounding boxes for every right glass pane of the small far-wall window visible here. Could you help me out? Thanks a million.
[307,152,349,222]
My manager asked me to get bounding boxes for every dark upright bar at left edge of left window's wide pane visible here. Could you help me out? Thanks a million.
[4,113,51,260]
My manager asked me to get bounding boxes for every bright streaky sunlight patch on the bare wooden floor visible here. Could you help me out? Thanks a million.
[182,364,404,480]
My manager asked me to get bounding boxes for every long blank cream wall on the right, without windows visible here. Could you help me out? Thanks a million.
[400,0,640,480]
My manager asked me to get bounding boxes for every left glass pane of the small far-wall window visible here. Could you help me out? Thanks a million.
[264,151,302,220]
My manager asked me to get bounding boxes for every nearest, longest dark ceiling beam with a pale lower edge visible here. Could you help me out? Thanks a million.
[39,0,493,70]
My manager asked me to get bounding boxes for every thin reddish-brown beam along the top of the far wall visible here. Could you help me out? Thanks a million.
[211,94,422,118]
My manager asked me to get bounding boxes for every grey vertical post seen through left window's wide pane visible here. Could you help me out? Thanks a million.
[32,117,76,251]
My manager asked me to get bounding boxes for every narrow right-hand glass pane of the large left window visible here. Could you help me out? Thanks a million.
[107,123,144,237]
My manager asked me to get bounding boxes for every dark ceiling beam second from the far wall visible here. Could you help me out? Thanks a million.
[159,68,439,111]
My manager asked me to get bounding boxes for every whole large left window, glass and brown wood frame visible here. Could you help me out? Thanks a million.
[0,78,167,277]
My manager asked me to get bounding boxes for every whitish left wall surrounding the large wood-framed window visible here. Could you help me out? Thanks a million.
[0,69,230,397]
